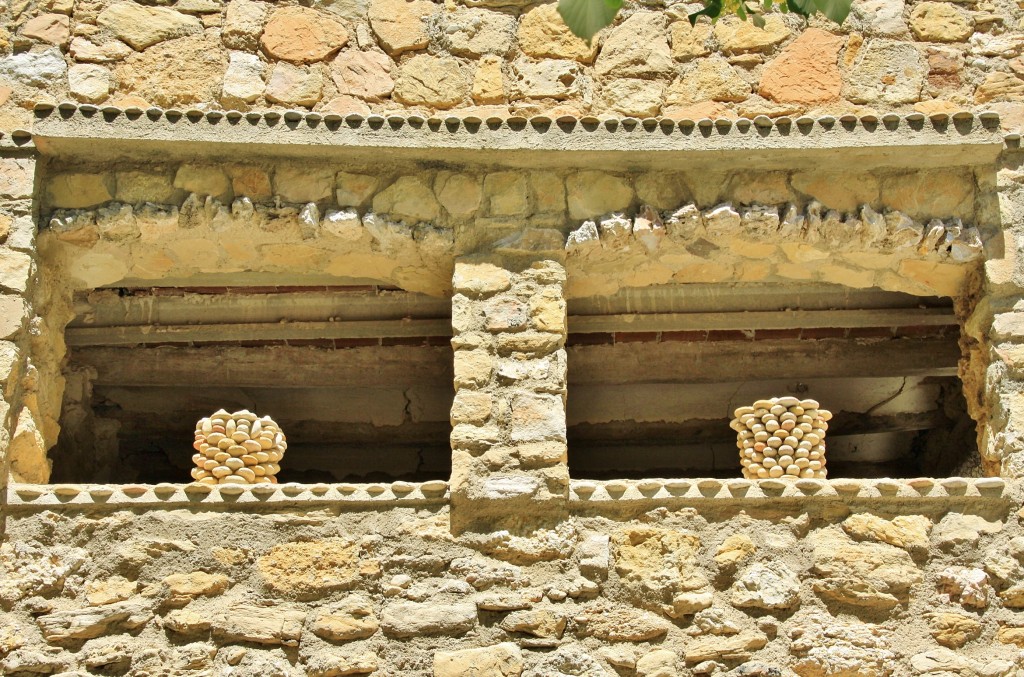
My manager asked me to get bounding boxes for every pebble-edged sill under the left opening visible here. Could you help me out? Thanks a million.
[5,479,449,512]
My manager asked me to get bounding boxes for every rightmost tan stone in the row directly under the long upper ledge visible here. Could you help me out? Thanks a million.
[882,170,975,220]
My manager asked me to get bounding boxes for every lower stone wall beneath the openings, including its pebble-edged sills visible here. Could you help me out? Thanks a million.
[0,479,1024,677]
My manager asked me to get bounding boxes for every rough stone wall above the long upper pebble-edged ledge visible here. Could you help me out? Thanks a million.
[0,0,1024,131]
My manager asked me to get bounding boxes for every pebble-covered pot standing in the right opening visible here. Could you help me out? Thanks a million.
[729,397,831,479]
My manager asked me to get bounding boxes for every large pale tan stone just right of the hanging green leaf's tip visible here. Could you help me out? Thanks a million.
[595,11,676,78]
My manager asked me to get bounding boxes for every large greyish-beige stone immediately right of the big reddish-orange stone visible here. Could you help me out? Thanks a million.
[843,38,928,105]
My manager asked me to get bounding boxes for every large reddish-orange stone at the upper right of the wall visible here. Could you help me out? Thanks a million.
[758,28,843,104]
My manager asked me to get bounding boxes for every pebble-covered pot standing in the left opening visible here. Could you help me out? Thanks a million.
[191,410,288,484]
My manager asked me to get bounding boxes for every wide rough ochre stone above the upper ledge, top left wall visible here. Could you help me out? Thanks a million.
[115,35,227,108]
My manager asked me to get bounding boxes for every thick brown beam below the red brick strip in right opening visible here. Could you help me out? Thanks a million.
[567,338,961,388]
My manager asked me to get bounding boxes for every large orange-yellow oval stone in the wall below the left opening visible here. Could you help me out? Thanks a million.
[256,538,370,599]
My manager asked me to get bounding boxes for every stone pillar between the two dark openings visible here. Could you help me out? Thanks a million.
[452,258,569,528]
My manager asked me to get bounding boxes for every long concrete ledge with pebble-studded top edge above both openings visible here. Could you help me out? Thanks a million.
[34,103,1004,169]
